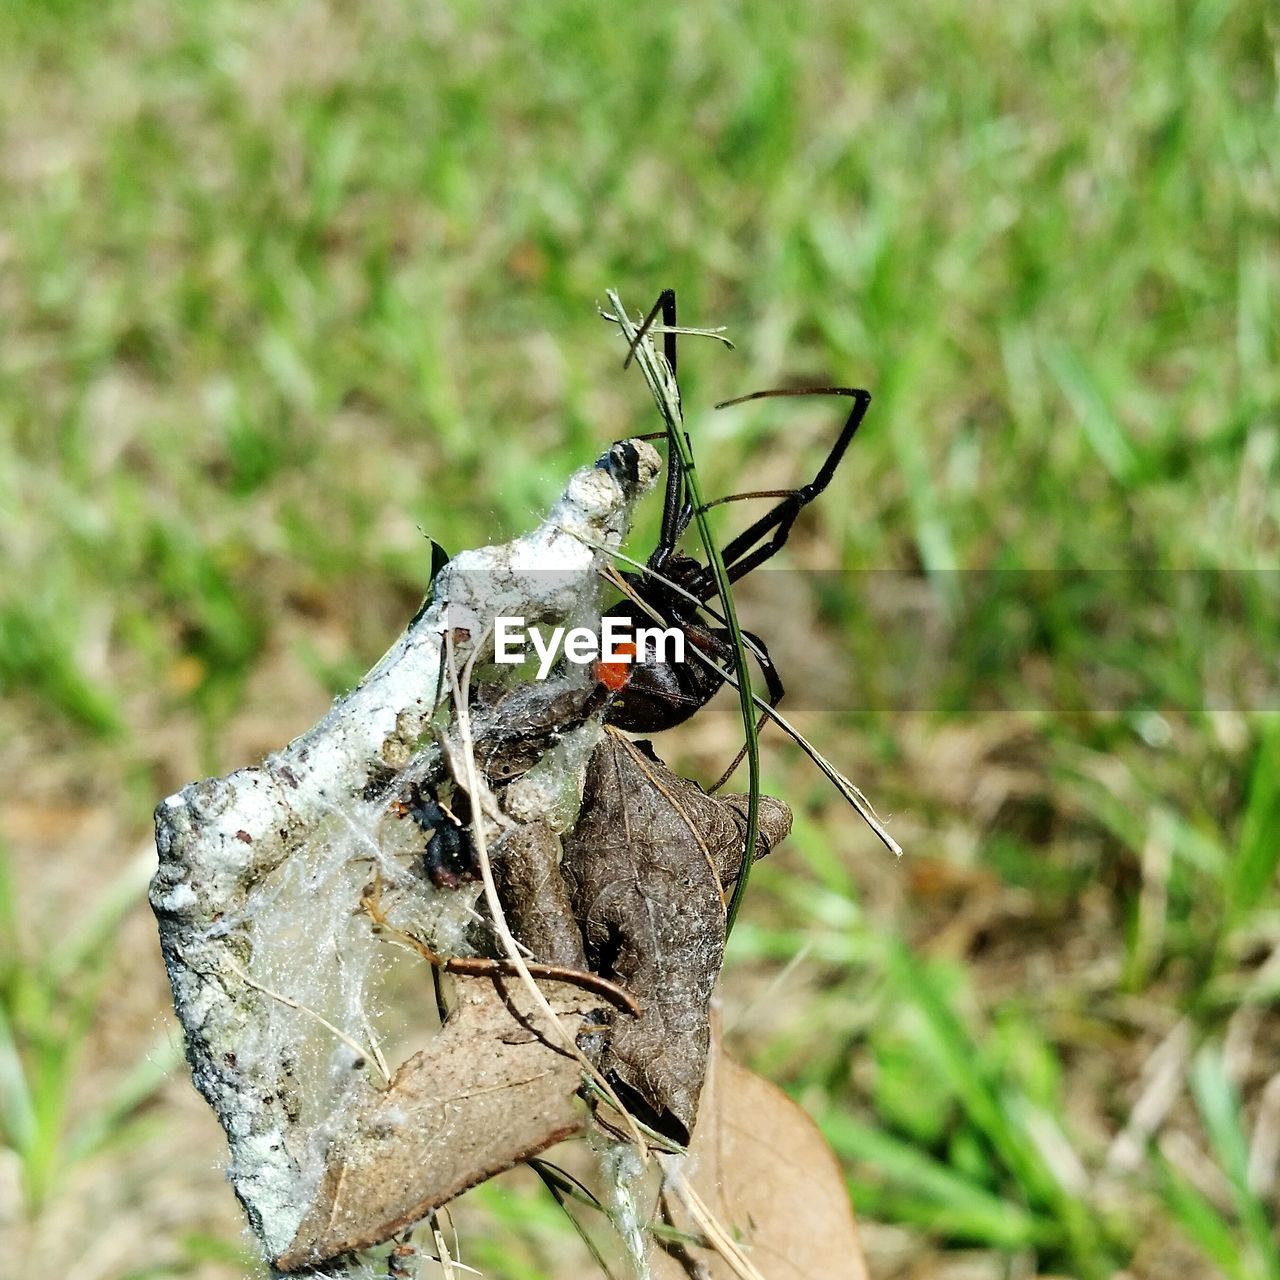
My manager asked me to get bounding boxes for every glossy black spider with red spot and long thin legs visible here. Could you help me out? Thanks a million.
[594,289,872,733]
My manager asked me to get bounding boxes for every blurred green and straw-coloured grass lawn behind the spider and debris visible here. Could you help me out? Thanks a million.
[0,0,1280,1277]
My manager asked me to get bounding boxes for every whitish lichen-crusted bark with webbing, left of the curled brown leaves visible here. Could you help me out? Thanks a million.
[151,442,659,1258]
